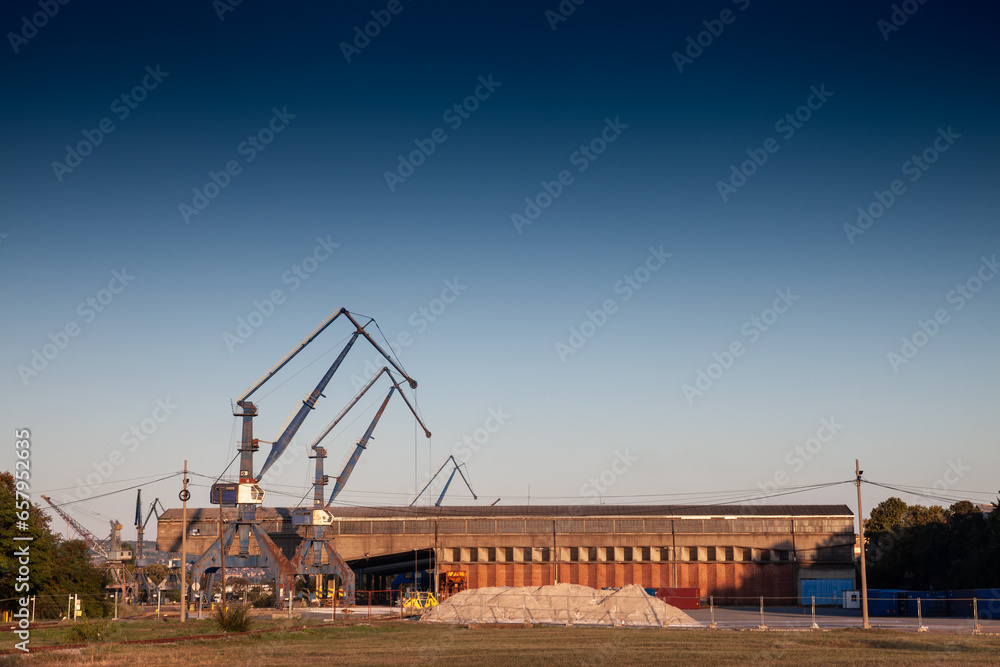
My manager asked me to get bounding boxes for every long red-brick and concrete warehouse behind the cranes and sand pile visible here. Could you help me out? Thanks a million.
[157,505,855,604]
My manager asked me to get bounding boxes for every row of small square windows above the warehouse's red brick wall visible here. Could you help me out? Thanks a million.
[442,547,789,563]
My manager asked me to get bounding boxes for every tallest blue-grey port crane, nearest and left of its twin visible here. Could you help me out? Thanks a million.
[191,308,426,604]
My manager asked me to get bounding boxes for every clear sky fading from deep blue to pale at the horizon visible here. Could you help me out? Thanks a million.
[0,0,1000,537]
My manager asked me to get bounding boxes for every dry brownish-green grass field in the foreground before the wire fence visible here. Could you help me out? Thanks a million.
[0,620,1000,667]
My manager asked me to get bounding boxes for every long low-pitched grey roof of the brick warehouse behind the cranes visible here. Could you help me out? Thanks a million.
[159,505,854,523]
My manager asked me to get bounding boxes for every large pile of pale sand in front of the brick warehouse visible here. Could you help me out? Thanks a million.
[421,584,702,628]
